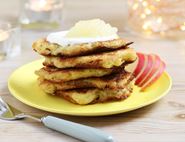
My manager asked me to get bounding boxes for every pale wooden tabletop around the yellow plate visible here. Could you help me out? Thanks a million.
[0,0,185,142]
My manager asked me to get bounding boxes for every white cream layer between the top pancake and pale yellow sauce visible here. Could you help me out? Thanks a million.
[46,31,118,47]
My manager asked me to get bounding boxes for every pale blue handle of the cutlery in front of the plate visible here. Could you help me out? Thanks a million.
[41,116,113,142]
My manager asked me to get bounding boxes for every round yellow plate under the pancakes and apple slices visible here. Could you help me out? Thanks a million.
[8,60,172,116]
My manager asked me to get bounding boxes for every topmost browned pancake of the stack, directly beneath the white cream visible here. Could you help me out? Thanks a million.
[32,38,133,57]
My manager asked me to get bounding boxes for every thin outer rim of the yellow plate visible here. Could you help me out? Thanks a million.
[8,59,172,116]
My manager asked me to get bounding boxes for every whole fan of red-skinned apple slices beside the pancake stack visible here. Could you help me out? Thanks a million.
[125,53,165,90]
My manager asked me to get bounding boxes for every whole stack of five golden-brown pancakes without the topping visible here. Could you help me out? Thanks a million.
[33,38,137,105]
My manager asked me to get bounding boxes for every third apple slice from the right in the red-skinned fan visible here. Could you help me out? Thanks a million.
[136,54,154,84]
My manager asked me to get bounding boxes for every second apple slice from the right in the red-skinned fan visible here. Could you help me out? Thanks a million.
[138,54,161,87]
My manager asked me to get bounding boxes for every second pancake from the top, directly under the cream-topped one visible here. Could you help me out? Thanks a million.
[43,48,137,68]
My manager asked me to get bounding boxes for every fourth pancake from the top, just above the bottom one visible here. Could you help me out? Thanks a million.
[38,72,134,94]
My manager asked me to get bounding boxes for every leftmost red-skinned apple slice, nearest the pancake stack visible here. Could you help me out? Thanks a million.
[134,53,148,80]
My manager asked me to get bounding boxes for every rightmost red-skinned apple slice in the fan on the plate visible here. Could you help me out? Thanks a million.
[141,61,166,90]
